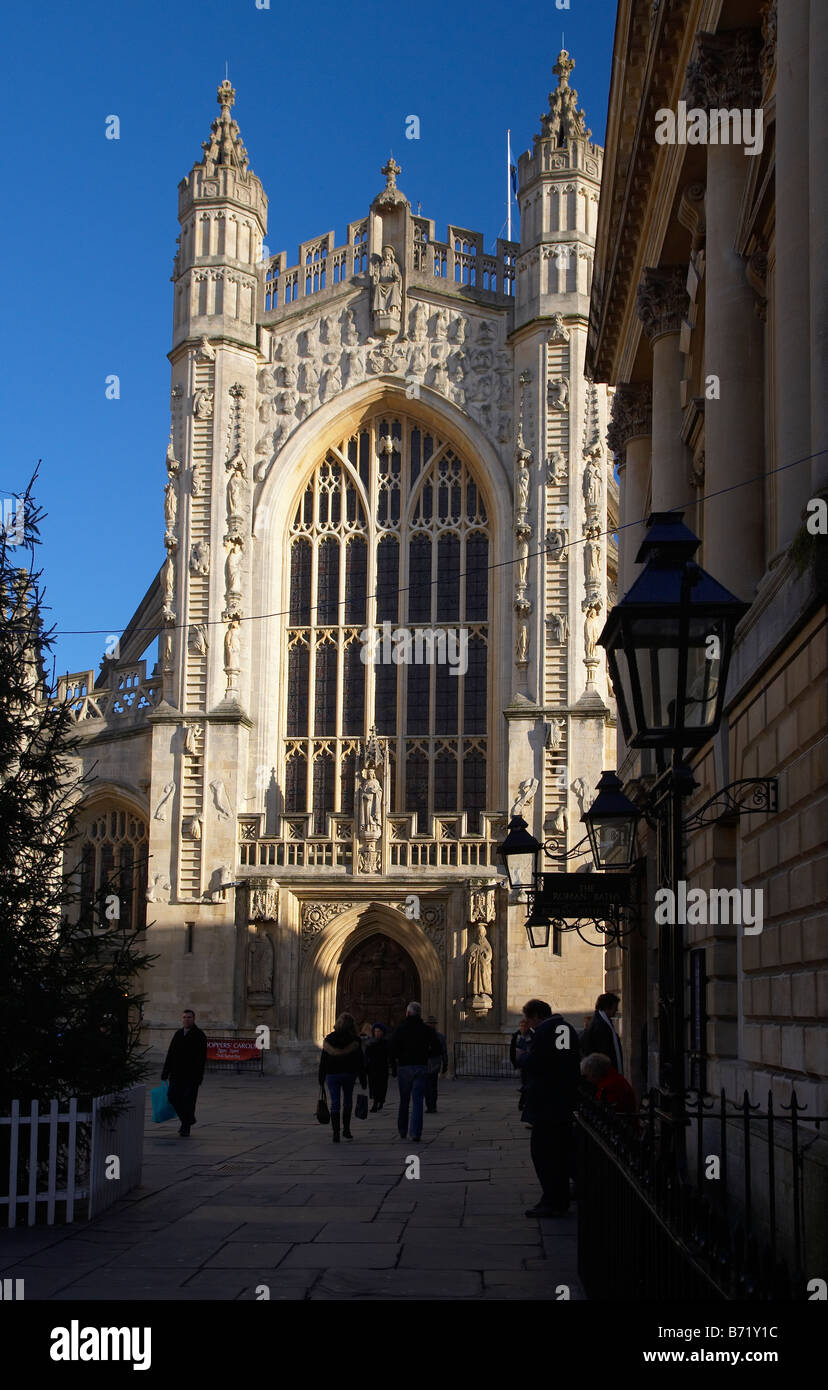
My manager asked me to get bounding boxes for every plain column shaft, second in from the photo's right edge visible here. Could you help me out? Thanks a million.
[774,0,811,549]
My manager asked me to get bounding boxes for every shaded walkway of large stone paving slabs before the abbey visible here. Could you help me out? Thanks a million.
[0,1074,583,1301]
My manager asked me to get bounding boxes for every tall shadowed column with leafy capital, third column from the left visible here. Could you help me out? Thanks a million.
[684,29,765,599]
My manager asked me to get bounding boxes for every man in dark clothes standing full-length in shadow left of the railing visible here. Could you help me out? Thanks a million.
[517,999,581,1216]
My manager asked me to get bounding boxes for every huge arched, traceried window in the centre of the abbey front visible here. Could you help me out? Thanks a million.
[283,414,490,834]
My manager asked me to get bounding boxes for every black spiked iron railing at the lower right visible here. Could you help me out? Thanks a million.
[575,1090,825,1301]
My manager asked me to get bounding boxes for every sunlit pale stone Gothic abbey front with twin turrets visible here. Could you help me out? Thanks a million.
[63,51,617,1069]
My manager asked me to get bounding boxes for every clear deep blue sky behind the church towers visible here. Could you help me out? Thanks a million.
[0,0,615,674]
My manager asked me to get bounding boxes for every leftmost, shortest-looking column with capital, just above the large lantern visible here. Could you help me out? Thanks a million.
[607,381,653,598]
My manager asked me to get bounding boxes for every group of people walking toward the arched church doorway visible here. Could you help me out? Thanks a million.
[318,1001,449,1144]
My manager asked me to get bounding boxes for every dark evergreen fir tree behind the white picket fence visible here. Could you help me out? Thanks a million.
[0,473,156,1112]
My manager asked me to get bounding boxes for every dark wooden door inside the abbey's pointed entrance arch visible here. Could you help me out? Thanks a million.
[336,931,421,1033]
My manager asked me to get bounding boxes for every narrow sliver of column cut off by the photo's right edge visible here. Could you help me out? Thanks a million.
[811,0,828,493]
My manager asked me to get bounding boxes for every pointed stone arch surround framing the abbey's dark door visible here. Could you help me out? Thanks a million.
[299,902,446,1044]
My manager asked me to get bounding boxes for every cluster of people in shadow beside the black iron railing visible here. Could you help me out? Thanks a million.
[511,994,635,1216]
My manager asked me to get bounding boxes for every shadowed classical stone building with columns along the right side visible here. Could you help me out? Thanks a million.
[586,0,828,1273]
